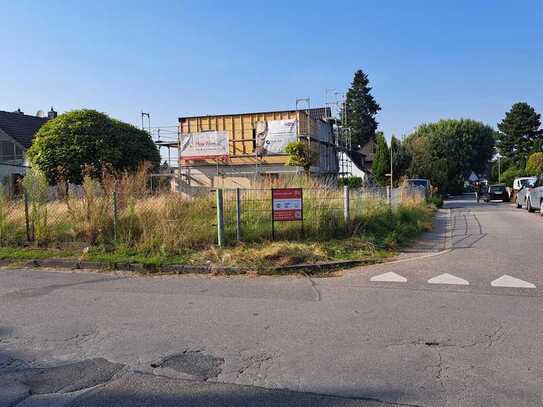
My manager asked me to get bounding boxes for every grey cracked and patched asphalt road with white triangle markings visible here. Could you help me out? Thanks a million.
[0,197,543,407]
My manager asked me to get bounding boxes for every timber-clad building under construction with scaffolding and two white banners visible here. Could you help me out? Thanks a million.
[172,108,346,188]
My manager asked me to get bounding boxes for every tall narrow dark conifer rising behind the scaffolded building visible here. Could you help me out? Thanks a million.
[342,70,381,149]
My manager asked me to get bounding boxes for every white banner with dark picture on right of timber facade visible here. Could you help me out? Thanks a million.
[255,119,298,156]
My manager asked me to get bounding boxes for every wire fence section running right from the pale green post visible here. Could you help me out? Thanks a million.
[216,187,425,245]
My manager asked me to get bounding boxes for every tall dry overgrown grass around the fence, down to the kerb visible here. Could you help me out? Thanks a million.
[0,168,432,268]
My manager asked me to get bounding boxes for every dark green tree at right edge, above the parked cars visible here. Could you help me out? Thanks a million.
[497,102,542,166]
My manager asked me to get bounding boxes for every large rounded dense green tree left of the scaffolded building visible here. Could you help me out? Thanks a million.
[28,109,160,184]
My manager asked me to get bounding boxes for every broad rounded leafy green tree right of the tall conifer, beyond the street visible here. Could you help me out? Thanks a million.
[406,119,495,193]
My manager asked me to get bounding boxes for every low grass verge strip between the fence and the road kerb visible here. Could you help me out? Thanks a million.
[0,205,434,271]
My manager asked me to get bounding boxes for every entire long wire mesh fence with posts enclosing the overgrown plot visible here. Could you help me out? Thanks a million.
[0,182,424,253]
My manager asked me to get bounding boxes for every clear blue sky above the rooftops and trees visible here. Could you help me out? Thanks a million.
[0,0,543,144]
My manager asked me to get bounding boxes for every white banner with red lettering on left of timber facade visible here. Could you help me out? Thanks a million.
[179,131,228,160]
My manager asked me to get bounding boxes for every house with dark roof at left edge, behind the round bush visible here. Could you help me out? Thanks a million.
[0,108,57,189]
